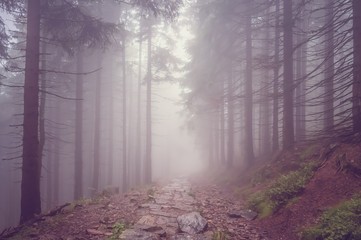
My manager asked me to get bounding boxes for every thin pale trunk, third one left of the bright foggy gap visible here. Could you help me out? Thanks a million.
[122,37,128,192]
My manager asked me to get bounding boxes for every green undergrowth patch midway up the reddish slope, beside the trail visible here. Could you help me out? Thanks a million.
[248,162,319,218]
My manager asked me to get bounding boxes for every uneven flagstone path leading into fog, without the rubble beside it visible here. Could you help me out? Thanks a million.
[120,178,212,240]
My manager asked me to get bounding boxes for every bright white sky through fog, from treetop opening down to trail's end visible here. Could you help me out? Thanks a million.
[154,4,202,178]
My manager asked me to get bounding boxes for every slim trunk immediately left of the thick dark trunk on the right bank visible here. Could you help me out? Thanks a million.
[272,0,280,152]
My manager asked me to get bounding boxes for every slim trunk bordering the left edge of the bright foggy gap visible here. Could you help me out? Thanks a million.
[145,23,152,183]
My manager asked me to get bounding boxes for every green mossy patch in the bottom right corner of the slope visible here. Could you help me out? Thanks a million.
[301,195,361,240]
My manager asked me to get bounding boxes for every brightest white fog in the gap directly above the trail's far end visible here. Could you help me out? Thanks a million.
[154,83,202,179]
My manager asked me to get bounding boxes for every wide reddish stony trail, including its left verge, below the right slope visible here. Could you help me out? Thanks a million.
[0,178,267,240]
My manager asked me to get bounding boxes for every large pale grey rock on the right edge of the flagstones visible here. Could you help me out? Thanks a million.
[177,212,207,234]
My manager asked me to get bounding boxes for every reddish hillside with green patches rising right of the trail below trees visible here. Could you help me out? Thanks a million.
[193,142,361,239]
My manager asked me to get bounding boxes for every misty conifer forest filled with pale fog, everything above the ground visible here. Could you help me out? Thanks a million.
[0,0,354,232]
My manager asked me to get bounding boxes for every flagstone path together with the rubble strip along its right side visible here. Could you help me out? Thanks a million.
[120,178,266,240]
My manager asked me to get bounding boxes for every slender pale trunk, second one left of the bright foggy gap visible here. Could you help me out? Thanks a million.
[135,33,143,185]
